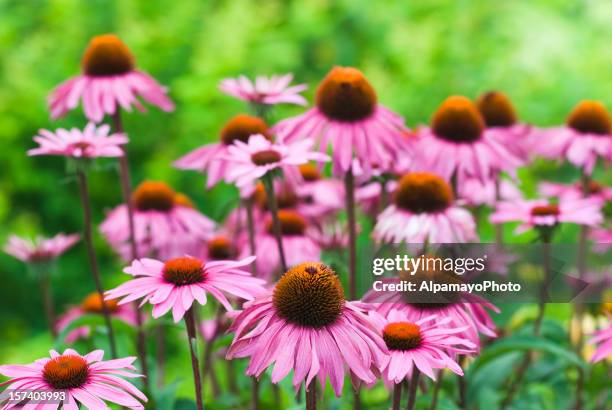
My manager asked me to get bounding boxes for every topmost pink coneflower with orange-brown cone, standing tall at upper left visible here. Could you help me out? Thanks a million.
[48,34,174,122]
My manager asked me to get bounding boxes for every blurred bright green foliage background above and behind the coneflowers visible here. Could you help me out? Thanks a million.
[0,0,612,406]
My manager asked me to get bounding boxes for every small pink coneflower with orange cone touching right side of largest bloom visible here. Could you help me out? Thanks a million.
[369,310,476,385]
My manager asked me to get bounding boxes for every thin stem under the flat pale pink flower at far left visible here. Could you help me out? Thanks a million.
[77,169,117,359]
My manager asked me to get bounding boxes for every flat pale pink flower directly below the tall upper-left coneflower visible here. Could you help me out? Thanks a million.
[28,122,128,159]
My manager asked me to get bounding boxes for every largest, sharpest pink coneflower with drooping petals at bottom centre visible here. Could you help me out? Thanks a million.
[227,262,386,396]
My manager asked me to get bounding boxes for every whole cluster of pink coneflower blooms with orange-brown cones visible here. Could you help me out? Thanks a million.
[0,35,612,409]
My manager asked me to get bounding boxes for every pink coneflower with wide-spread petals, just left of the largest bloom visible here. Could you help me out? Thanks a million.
[106,256,265,322]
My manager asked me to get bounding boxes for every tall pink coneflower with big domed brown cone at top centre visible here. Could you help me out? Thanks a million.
[274,67,406,175]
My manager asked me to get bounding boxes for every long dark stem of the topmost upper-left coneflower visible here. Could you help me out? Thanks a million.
[112,109,149,390]
